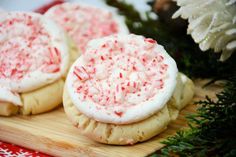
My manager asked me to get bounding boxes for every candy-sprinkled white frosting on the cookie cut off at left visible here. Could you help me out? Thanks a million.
[0,12,69,105]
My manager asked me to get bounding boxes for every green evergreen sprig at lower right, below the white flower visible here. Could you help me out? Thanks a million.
[160,71,236,157]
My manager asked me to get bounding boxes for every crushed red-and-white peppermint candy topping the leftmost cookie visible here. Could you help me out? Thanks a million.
[0,12,61,80]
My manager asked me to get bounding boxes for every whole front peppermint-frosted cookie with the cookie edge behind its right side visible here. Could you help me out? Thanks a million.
[63,35,194,145]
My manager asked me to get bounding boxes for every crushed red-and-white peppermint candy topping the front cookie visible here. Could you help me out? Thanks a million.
[73,35,168,106]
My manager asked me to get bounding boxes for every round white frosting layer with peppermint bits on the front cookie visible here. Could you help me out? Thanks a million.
[66,35,178,124]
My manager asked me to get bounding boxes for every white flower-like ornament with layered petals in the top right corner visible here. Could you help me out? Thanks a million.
[173,0,236,61]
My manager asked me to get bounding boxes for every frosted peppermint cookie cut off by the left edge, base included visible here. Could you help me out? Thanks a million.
[0,12,70,116]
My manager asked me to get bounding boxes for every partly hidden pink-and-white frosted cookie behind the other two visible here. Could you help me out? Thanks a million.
[45,3,128,53]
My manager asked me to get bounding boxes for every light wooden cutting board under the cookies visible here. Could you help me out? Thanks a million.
[0,80,220,157]
